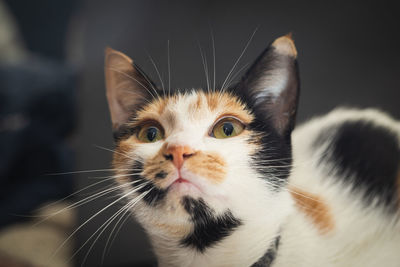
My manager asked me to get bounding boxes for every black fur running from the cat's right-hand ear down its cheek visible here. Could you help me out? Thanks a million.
[229,42,300,191]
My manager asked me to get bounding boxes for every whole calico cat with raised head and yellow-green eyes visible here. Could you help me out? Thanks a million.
[105,36,400,267]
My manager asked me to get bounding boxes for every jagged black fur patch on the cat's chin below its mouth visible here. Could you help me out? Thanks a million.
[181,196,242,252]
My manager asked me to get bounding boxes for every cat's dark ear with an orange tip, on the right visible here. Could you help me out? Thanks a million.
[236,34,300,136]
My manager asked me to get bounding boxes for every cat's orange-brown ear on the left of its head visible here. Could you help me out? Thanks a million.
[104,47,156,131]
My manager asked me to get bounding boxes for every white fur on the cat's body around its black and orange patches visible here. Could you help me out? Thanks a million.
[273,109,400,267]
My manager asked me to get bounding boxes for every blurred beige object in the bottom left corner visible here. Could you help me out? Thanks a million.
[0,203,76,267]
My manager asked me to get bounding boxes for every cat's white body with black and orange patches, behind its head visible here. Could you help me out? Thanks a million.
[287,109,400,266]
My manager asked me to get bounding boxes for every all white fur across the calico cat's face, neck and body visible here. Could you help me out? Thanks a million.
[121,100,400,267]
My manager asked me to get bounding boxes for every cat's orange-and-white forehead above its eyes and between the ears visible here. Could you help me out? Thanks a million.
[136,90,253,128]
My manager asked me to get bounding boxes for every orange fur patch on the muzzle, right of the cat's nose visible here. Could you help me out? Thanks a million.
[185,151,226,184]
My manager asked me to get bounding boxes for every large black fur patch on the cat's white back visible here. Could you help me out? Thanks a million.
[314,121,400,207]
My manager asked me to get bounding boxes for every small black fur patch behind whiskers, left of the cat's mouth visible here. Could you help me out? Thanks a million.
[130,161,167,206]
